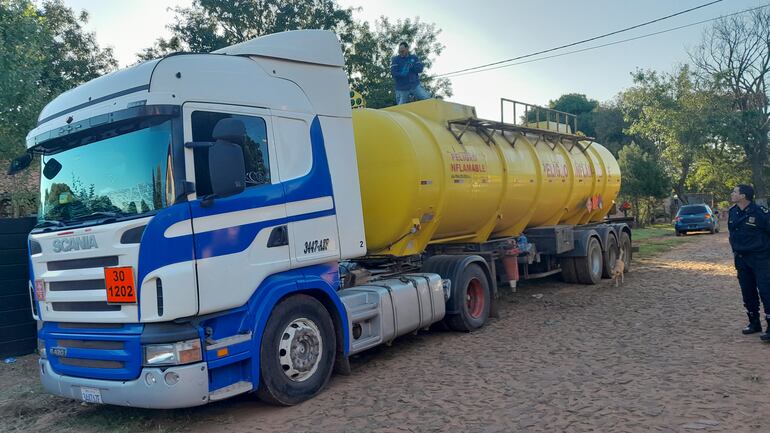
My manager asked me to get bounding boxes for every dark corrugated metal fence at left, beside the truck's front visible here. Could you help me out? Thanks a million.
[0,218,37,358]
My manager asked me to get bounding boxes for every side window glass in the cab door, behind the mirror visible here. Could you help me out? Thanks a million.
[191,111,270,196]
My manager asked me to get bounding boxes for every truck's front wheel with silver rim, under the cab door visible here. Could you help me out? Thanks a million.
[257,295,337,406]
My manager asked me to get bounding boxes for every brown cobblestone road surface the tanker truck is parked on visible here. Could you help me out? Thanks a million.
[0,234,770,432]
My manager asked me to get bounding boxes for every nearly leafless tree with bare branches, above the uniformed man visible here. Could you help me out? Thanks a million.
[690,8,770,197]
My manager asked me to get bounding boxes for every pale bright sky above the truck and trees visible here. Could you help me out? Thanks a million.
[64,0,770,119]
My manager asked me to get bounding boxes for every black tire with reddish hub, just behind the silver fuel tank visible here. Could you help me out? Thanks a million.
[444,263,492,332]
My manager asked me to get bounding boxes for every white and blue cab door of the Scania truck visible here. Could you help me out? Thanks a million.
[183,103,290,314]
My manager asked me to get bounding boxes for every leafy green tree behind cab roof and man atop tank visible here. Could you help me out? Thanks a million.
[137,0,452,108]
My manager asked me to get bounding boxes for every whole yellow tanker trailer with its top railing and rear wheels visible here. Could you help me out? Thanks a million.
[344,100,631,329]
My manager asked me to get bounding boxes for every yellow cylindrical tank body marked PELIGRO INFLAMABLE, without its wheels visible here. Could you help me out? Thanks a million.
[353,100,620,256]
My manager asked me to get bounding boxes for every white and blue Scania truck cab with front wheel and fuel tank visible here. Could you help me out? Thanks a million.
[12,30,447,408]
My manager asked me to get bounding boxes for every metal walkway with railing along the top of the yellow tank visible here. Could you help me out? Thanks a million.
[440,98,593,152]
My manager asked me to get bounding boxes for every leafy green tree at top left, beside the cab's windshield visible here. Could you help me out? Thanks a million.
[0,0,117,159]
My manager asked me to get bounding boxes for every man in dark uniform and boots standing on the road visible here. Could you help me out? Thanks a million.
[727,185,770,342]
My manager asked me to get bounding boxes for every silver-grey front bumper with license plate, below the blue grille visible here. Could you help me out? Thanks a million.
[39,359,209,409]
